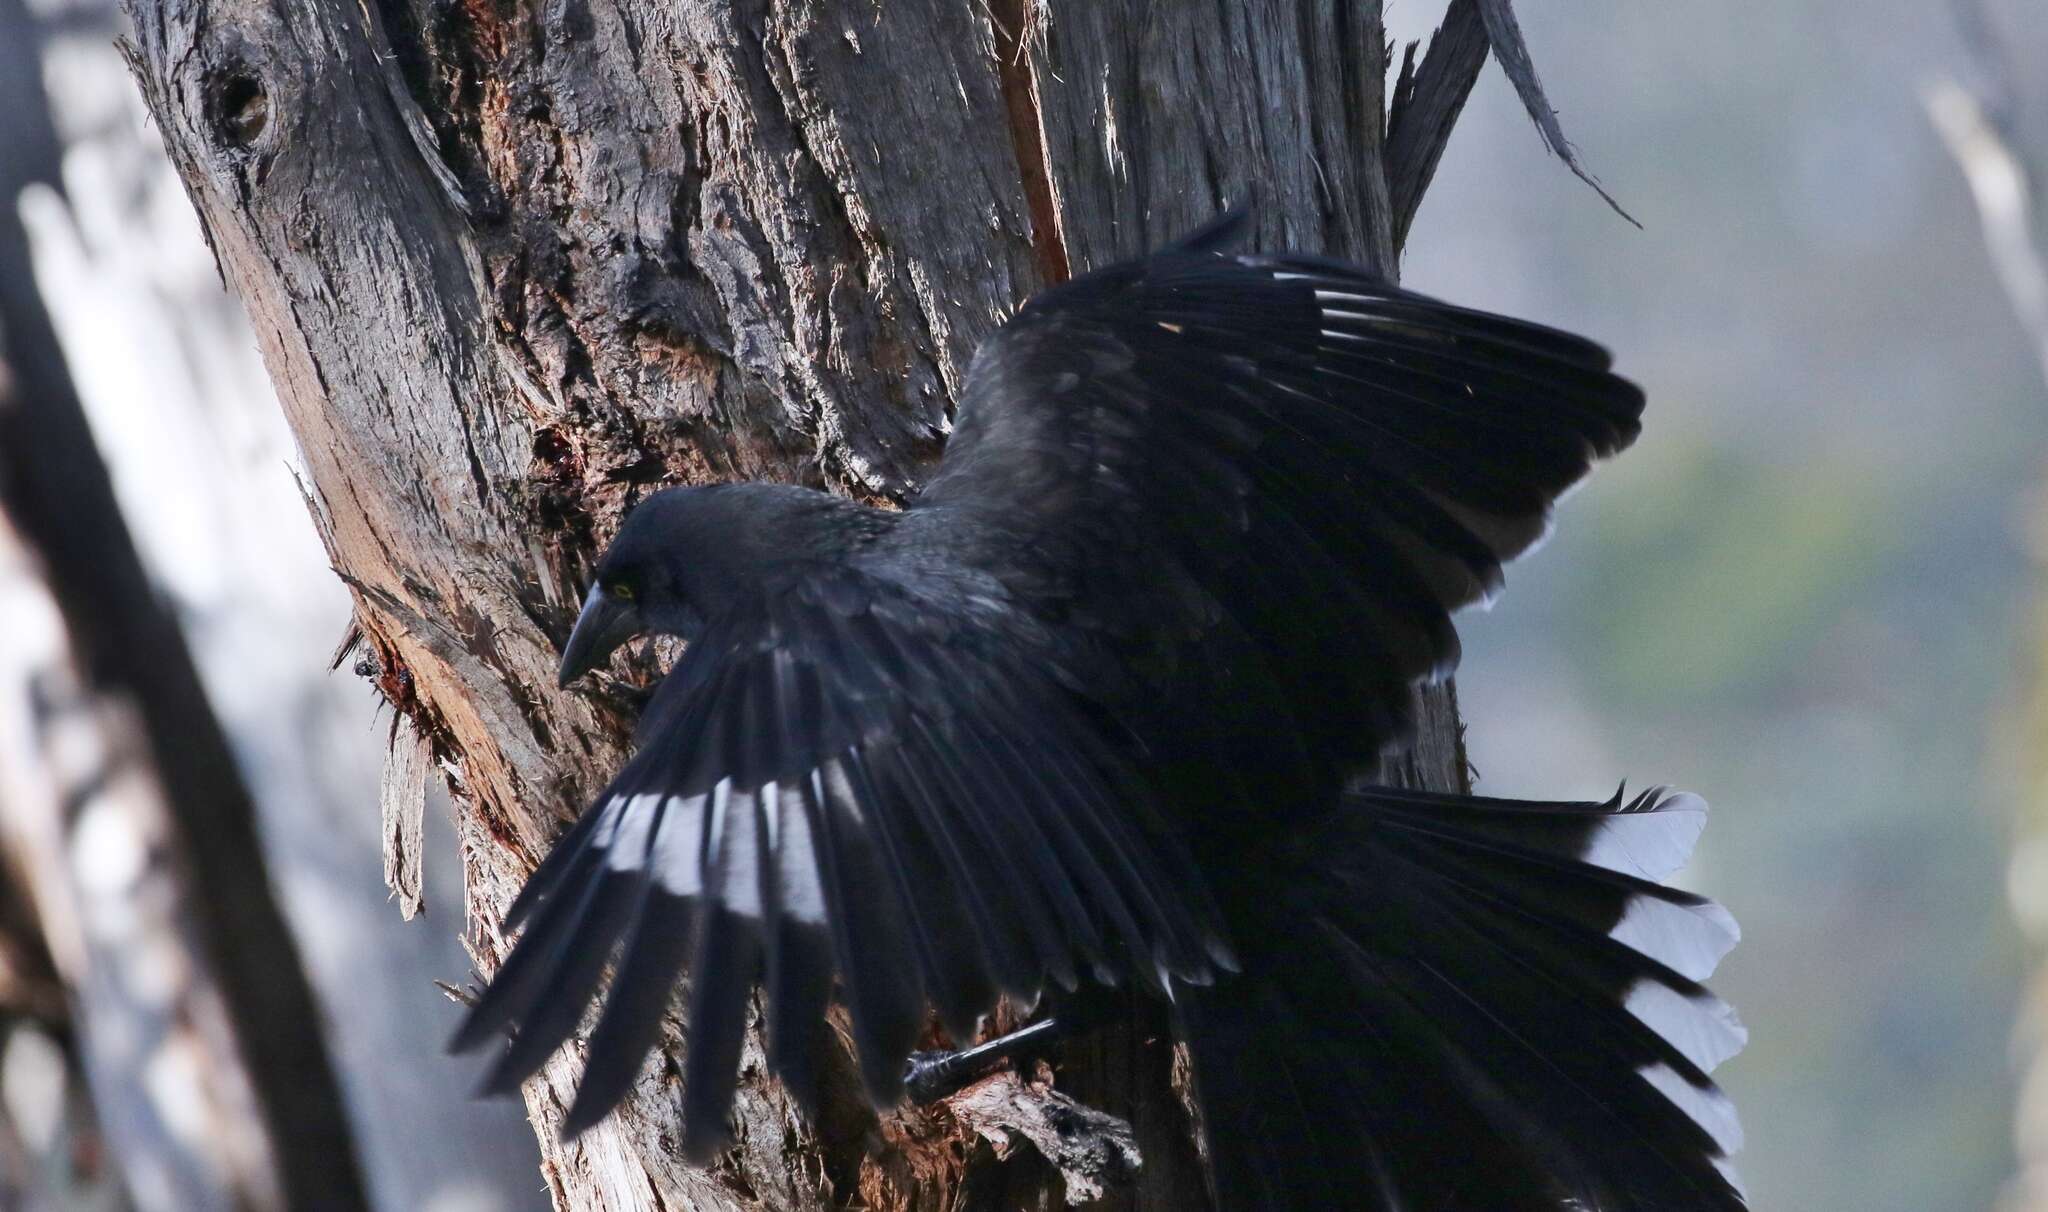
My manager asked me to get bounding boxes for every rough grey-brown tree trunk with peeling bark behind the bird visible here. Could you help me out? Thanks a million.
[127,0,1505,1210]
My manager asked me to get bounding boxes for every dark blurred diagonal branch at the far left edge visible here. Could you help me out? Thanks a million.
[0,0,362,1210]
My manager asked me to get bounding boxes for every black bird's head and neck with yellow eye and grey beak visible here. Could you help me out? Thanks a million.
[559,483,887,686]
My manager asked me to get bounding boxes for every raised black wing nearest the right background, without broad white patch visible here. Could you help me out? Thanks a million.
[911,219,1642,809]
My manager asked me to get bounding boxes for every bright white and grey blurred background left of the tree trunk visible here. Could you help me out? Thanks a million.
[0,0,549,1212]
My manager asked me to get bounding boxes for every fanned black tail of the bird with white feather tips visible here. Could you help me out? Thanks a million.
[1180,788,1745,1212]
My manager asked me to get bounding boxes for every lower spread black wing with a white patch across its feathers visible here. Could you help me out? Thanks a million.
[455,567,1229,1157]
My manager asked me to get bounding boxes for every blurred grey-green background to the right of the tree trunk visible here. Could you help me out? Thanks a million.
[1395,0,2048,1212]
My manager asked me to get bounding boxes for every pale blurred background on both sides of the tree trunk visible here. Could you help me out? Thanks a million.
[0,0,2048,1212]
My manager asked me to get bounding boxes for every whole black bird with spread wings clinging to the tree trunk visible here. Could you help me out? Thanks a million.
[457,215,1743,1212]
